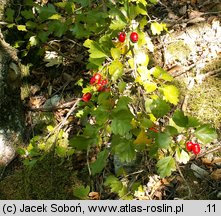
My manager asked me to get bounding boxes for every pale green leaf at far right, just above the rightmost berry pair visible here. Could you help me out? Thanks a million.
[194,124,217,144]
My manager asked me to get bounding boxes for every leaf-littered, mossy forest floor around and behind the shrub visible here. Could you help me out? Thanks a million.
[0,1,221,200]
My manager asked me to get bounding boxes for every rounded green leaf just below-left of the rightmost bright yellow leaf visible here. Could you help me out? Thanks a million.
[150,98,170,118]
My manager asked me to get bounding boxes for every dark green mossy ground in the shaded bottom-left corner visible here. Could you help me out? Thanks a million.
[0,155,82,200]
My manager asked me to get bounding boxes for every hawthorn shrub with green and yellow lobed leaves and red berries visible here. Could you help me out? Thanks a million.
[6,0,217,198]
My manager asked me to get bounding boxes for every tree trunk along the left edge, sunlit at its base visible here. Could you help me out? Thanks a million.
[0,0,24,166]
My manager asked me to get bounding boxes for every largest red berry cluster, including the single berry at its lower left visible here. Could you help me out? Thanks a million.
[82,73,110,102]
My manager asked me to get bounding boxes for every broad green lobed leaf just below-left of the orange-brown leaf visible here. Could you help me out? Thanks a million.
[111,136,136,162]
